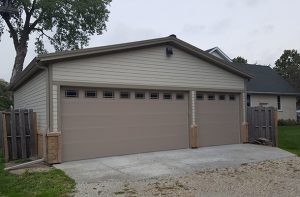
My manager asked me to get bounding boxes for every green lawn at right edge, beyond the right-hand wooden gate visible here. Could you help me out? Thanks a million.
[278,125,300,157]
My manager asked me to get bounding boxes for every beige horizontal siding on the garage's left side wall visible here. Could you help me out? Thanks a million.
[14,71,47,132]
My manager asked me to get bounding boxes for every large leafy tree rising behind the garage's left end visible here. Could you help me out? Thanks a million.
[0,0,111,82]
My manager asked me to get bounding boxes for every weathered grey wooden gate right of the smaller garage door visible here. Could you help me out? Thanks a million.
[247,106,278,146]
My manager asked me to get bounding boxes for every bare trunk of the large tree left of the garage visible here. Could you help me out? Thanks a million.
[10,44,27,83]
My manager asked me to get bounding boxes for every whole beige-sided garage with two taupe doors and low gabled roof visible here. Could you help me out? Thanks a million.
[11,35,252,162]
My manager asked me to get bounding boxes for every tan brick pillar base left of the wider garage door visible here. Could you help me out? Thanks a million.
[47,132,61,164]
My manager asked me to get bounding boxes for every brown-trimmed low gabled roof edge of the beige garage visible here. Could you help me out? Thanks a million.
[10,35,252,90]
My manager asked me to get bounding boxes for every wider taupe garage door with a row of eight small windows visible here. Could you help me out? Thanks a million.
[61,88,189,161]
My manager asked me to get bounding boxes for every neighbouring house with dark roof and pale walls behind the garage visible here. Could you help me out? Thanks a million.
[207,47,300,120]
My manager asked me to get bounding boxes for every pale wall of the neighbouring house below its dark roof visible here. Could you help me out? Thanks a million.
[251,95,296,120]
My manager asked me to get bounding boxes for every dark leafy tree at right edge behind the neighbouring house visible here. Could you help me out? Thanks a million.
[274,49,300,106]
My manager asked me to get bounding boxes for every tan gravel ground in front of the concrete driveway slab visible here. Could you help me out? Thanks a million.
[75,157,300,197]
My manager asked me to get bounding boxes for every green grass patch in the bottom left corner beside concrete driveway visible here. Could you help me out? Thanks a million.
[0,155,75,197]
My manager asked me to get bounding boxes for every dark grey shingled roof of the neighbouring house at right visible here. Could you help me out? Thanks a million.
[232,63,300,95]
